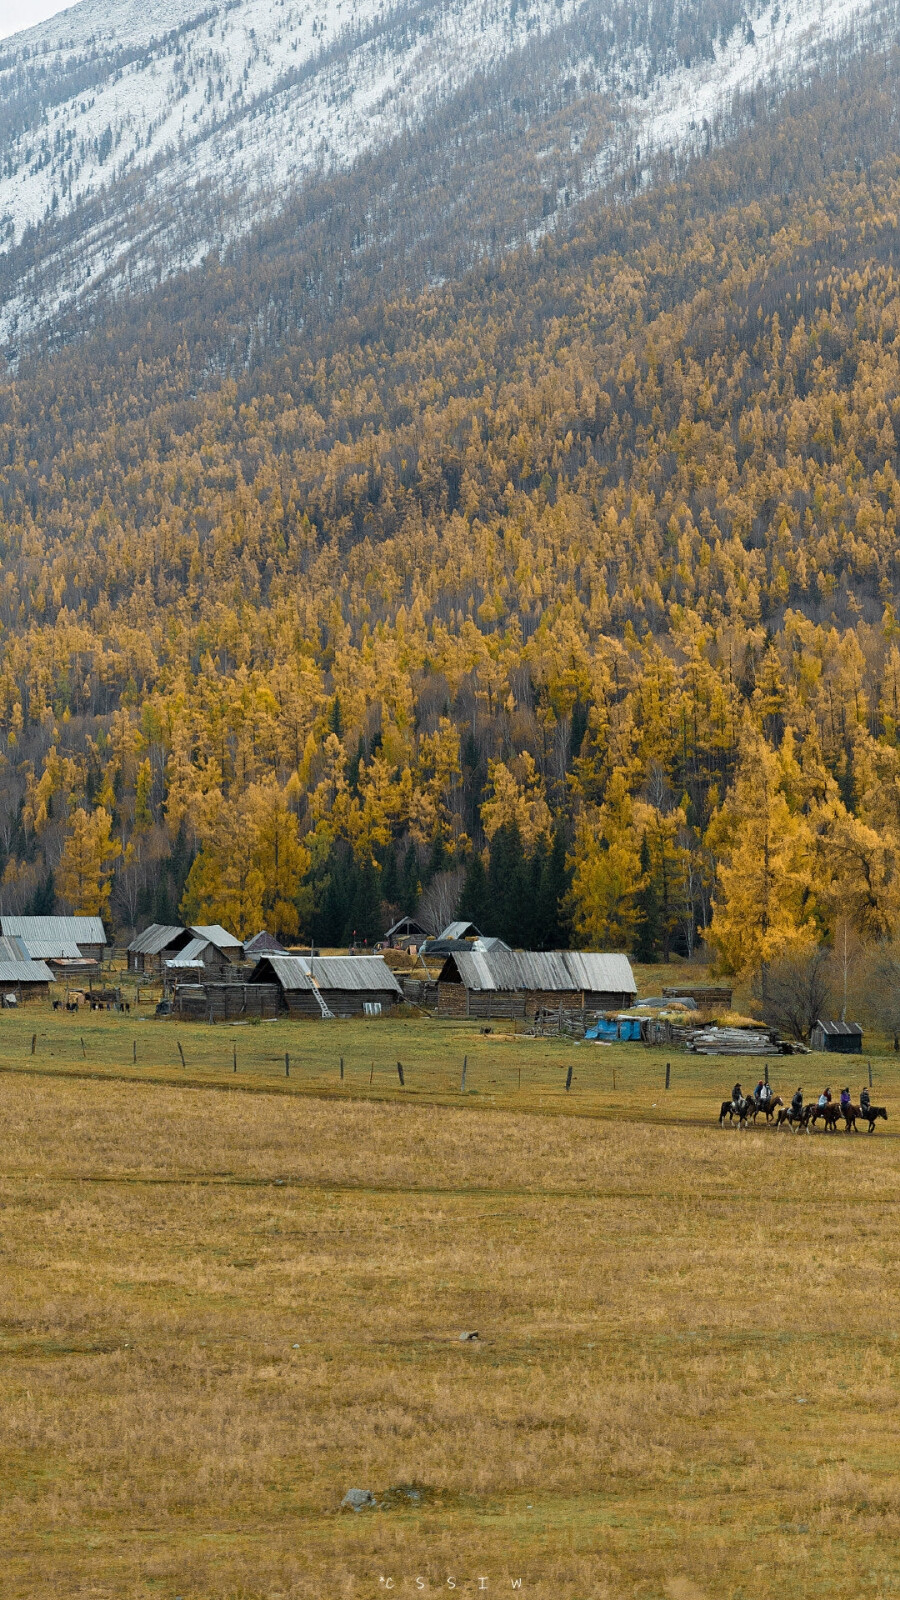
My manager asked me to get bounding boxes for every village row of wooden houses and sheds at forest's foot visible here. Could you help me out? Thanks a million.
[0,914,863,1056]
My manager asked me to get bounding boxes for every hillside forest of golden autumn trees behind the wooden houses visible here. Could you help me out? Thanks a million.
[0,31,900,974]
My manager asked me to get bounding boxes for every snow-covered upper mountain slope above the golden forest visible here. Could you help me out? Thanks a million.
[0,0,882,354]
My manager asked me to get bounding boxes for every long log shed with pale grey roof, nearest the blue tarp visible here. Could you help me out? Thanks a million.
[437,949,637,1018]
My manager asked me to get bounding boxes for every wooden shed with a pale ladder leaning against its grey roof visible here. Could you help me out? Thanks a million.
[248,955,404,1018]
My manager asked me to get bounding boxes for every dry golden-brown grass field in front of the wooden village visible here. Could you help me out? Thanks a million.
[0,1006,900,1600]
